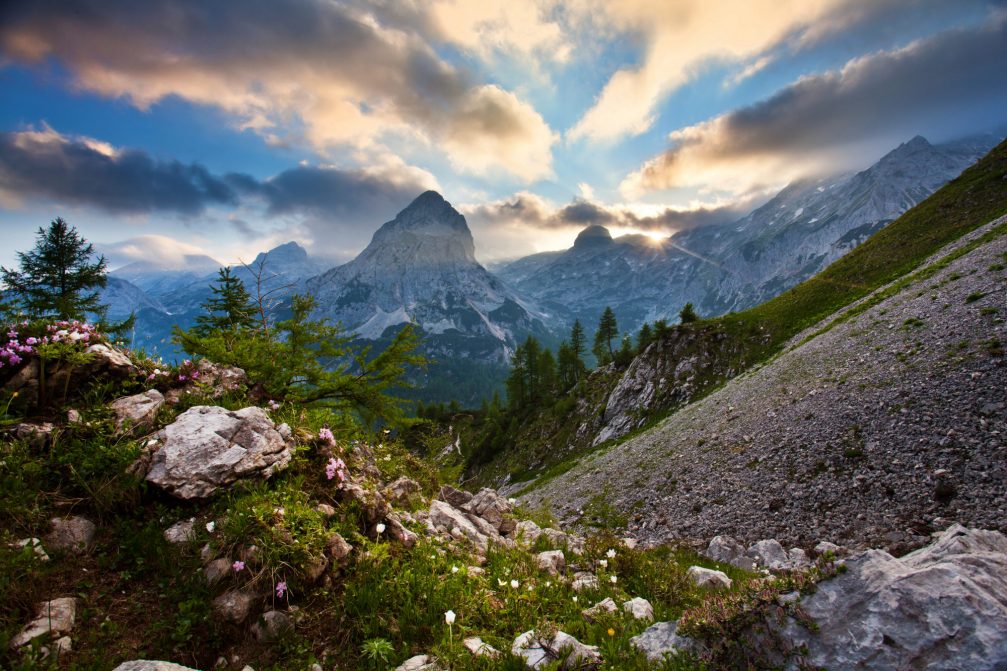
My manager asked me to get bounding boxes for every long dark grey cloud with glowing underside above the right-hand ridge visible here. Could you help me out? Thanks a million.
[620,16,1007,197]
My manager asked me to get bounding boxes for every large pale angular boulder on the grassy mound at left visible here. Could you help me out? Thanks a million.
[147,405,292,500]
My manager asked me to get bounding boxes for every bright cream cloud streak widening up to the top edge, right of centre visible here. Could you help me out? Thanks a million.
[568,0,860,141]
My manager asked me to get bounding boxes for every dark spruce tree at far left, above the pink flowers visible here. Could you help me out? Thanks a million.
[0,217,109,321]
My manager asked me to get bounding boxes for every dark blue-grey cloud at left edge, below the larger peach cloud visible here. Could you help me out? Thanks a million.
[0,126,238,211]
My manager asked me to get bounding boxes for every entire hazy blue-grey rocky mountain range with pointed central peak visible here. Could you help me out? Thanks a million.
[103,135,996,403]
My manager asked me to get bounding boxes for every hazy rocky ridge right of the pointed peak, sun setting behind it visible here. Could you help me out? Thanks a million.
[497,135,997,329]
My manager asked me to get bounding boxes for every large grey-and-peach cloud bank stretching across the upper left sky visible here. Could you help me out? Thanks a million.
[0,0,555,181]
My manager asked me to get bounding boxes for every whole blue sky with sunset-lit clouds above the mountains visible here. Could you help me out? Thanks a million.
[0,0,1007,268]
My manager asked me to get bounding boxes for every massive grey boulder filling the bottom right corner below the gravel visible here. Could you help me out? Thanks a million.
[783,525,1007,671]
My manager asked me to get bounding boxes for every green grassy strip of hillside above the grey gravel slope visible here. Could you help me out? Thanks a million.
[471,141,1007,482]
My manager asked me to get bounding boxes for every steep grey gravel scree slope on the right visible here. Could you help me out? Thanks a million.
[523,218,1007,553]
